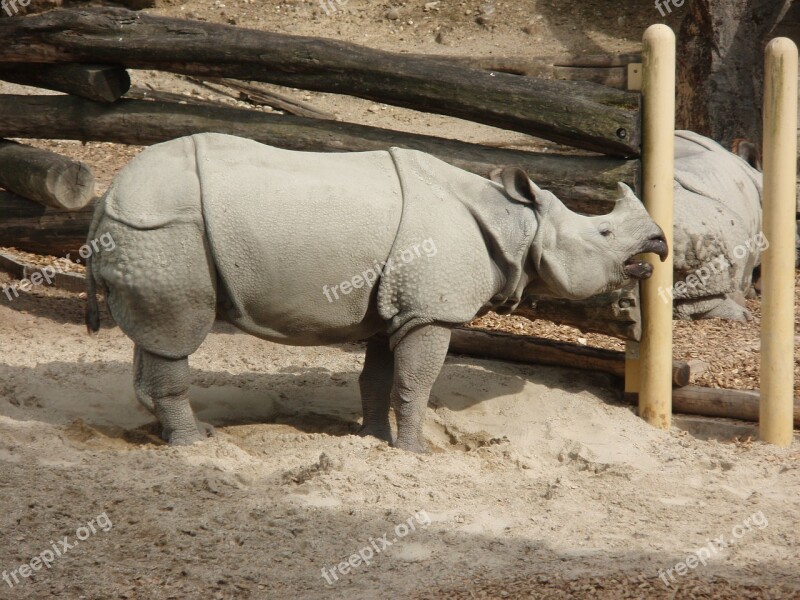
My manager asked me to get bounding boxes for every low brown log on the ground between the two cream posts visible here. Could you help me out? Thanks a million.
[626,385,800,429]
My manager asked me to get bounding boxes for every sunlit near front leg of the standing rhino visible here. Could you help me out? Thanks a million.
[392,325,450,452]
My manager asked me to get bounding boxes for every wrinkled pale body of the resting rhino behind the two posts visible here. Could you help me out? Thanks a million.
[673,131,766,320]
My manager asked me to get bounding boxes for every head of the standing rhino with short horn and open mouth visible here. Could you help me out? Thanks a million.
[491,167,668,300]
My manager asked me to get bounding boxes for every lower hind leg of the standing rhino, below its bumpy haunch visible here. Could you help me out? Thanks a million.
[133,347,211,446]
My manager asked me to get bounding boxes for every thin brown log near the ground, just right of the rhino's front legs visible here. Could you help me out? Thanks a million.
[450,327,691,386]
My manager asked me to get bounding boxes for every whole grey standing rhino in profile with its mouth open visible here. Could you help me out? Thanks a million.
[87,134,667,452]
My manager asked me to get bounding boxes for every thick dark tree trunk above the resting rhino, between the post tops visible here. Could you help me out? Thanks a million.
[676,0,791,148]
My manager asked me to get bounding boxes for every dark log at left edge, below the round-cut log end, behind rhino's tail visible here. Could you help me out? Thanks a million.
[0,191,94,257]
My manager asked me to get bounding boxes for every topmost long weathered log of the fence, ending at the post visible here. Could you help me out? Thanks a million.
[0,8,640,156]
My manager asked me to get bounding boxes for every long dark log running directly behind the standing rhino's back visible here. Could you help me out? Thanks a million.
[0,96,639,214]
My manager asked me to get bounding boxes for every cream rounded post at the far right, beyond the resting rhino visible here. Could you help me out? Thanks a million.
[759,38,797,446]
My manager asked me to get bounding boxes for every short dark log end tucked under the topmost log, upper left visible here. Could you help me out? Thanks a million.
[0,64,131,102]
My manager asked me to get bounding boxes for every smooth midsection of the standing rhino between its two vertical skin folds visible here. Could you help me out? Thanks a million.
[195,134,402,344]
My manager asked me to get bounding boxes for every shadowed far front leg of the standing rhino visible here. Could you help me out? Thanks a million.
[358,336,394,443]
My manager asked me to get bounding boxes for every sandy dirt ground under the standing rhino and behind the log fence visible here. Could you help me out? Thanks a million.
[0,0,800,600]
